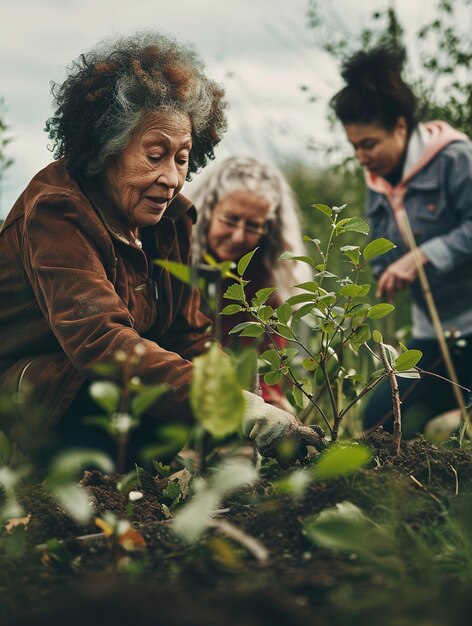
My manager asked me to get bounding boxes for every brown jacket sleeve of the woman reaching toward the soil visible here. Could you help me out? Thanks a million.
[22,196,199,420]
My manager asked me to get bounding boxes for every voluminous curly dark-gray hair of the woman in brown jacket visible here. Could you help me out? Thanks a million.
[46,31,226,180]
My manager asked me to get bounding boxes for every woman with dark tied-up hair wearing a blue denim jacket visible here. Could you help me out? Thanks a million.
[331,47,472,434]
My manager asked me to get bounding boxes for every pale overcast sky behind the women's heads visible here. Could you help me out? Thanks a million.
[0,0,448,217]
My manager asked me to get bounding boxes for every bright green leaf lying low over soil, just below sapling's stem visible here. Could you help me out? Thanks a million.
[313,444,372,480]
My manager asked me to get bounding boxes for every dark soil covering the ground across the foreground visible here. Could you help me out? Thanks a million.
[0,431,472,626]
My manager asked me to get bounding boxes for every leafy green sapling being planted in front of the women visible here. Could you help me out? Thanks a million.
[221,204,421,446]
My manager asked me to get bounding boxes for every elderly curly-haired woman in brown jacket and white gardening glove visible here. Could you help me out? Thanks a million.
[0,32,316,466]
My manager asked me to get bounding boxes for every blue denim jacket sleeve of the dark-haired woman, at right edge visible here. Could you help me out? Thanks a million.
[421,142,472,273]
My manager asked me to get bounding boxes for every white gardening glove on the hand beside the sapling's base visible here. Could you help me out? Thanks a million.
[242,391,322,467]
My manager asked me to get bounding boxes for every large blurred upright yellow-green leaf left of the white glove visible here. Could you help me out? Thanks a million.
[190,343,245,438]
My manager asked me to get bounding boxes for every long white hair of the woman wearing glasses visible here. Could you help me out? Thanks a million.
[186,157,312,301]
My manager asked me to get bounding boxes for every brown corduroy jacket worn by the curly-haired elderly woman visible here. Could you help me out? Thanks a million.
[0,160,209,444]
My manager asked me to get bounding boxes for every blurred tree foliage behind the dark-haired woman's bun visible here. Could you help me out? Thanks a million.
[308,0,472,136]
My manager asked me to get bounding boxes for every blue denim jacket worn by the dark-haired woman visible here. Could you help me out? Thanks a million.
[366,136,472,320]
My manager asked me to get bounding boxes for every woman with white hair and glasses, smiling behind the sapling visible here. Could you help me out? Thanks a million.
[188,157,312,408]
